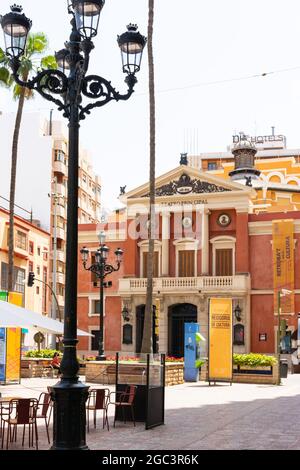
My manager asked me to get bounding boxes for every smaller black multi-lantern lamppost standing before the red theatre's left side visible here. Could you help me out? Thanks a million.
[80,232,123,361]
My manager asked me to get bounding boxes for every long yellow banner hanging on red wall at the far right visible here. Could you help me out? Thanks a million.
[272,220,295,314]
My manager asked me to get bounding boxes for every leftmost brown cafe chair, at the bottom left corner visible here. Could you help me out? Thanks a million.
[2,398,38,450]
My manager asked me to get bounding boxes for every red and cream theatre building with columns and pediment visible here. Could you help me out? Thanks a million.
[78,140,300,357]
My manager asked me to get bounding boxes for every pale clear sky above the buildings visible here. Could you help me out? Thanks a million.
[0,0,300,207]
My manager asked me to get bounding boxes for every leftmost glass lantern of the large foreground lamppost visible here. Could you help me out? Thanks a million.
[0,5,32,58]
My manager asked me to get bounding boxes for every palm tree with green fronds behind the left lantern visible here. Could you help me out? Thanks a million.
[0,33,57,292]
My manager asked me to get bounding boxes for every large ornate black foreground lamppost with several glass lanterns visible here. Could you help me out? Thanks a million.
[0,0,146,450]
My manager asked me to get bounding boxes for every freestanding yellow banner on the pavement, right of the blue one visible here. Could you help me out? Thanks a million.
[208,298,232,381]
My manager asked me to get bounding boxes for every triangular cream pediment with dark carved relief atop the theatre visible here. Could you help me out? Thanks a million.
[120,165,253,202]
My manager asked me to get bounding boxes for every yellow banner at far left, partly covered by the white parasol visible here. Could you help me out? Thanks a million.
[6,292,23,382]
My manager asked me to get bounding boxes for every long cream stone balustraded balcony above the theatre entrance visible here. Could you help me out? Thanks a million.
[119,274,250,295]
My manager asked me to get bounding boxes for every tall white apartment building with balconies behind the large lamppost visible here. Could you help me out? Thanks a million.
[0,112,101,320]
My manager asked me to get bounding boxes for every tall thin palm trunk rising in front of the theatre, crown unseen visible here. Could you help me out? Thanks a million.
[141,0,155,353]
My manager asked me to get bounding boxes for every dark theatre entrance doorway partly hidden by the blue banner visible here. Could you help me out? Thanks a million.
[168,304,197,357]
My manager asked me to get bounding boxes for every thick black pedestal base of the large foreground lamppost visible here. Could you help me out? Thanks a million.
[51,378,89,450]
